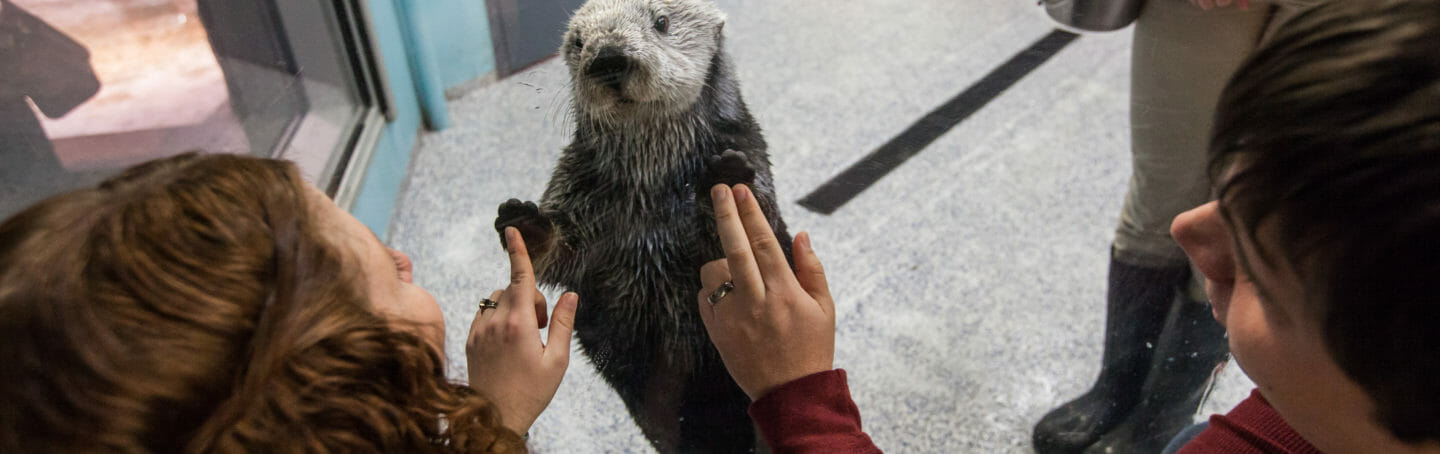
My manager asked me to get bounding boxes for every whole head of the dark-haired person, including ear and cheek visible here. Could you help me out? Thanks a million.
[1172,0,1440,445]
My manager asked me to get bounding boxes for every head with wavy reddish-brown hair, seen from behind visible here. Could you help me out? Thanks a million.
[0,154,523,453]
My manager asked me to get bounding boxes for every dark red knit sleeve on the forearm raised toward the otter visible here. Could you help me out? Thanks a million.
[750,369,880,454]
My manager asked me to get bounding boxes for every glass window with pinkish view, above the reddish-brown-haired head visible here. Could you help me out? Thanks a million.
[0,0,363,218]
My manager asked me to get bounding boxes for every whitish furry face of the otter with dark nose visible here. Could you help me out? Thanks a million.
[560,0,724,118]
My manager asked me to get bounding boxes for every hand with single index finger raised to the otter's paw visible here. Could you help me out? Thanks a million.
[465,228,579,434]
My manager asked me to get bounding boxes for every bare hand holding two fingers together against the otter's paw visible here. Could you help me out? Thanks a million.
[700,184,835,401]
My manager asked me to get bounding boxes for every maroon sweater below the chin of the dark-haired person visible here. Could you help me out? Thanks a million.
[1178,389,1320,454]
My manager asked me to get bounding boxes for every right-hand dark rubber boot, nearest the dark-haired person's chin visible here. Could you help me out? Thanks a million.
[1086,301,1230,454]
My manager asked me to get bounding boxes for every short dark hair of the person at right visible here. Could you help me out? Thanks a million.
[1210,0,1440,442]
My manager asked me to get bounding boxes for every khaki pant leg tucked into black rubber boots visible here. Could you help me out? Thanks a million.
[1115,0,1272,301]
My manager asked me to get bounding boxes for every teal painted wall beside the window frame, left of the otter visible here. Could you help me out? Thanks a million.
[351,0,495,238]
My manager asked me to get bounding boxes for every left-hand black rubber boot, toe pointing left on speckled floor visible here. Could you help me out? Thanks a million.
[1032,251,1189,454]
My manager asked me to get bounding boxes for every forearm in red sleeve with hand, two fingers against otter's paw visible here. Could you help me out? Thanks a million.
[698,184,880,453]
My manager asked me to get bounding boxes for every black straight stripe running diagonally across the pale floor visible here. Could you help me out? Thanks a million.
[799,30,1080,215]
